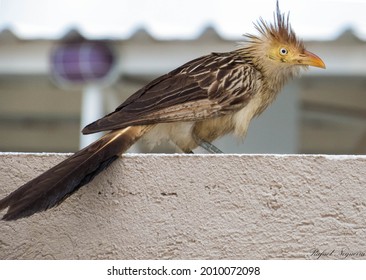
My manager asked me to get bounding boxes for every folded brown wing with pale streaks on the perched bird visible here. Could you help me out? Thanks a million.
[83,52,258,134]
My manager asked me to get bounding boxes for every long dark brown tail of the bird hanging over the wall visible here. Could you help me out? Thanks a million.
[0,126,149,220]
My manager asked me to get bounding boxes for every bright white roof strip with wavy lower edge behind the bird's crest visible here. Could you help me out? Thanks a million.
[0,0,366,40]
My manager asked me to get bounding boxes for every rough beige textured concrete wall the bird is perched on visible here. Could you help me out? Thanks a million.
[0,154,366,259]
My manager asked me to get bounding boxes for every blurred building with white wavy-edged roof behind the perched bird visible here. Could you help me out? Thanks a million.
[0,0,366,154]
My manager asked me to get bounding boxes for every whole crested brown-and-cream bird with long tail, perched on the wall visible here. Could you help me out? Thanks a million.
[0,3,325,220]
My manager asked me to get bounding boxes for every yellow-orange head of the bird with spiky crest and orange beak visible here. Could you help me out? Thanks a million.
[243,2,325,78]
